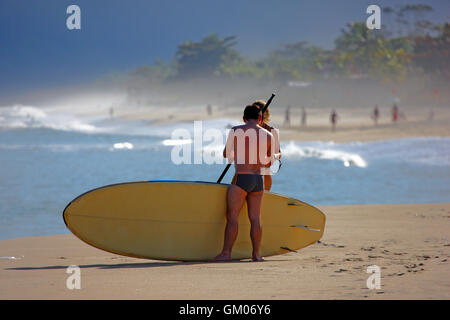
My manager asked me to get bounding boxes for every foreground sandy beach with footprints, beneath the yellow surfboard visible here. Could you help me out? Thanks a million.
[0,203,450,299]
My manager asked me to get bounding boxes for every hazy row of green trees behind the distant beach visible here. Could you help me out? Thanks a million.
[129,4,450,82]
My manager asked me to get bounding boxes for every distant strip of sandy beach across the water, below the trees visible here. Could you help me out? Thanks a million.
[117,106,450,142]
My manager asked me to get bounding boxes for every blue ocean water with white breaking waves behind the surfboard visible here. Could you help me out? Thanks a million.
[0,105,450,240]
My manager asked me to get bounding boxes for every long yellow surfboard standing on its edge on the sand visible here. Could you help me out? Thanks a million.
[63,181,325,261]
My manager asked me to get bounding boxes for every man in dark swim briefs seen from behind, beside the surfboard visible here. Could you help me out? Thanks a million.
[214,105,273,261]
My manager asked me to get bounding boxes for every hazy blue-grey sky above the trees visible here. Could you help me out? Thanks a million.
[0,0,450,96]
